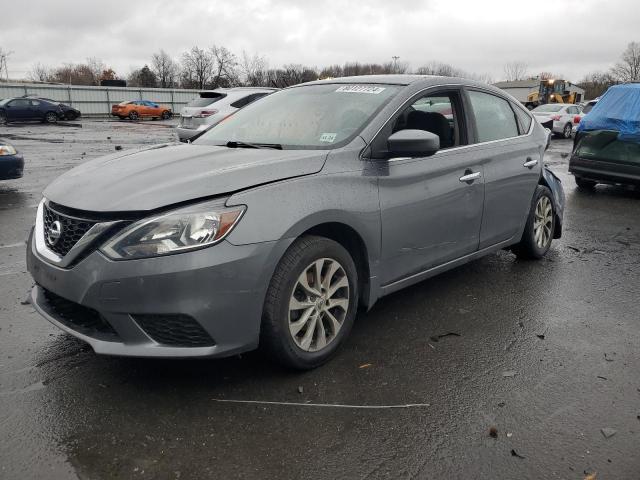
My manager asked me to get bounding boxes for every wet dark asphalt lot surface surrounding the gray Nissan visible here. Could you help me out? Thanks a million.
[0,121,640,480]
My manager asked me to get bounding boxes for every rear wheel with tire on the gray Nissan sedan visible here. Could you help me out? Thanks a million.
[512,185,555,260]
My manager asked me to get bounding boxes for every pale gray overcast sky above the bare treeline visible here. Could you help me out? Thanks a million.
[0,0,640,81]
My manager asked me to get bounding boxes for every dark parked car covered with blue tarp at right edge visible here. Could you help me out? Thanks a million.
[569,83,640,189]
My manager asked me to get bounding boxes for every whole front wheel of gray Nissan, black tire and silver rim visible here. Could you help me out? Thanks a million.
[260,236,358,370]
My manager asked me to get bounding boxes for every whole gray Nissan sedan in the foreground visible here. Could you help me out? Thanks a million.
[27,75,564,369]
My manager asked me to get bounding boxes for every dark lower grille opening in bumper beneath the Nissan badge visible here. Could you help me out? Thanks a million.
[42,288,120,342]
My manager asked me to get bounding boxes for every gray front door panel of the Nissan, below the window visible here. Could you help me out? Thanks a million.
[379,147,484,285]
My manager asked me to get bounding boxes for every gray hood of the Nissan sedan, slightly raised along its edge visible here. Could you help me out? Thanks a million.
[44,144,327,212]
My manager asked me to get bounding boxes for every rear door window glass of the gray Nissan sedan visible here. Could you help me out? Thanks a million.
[469,90,519,143]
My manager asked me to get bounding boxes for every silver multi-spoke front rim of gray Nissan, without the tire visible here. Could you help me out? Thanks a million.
[289,258,350,352]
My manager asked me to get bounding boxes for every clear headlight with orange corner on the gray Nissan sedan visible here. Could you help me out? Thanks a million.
[100,201,246,260]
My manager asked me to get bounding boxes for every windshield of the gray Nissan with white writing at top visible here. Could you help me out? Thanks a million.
[194,83,401,149]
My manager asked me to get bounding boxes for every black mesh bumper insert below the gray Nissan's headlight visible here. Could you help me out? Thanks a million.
[133,315,215,347]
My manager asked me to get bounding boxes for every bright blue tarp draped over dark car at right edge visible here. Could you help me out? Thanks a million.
[578,83,640,142]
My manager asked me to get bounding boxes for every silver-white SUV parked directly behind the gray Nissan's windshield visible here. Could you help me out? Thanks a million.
[177,87,277,141]
